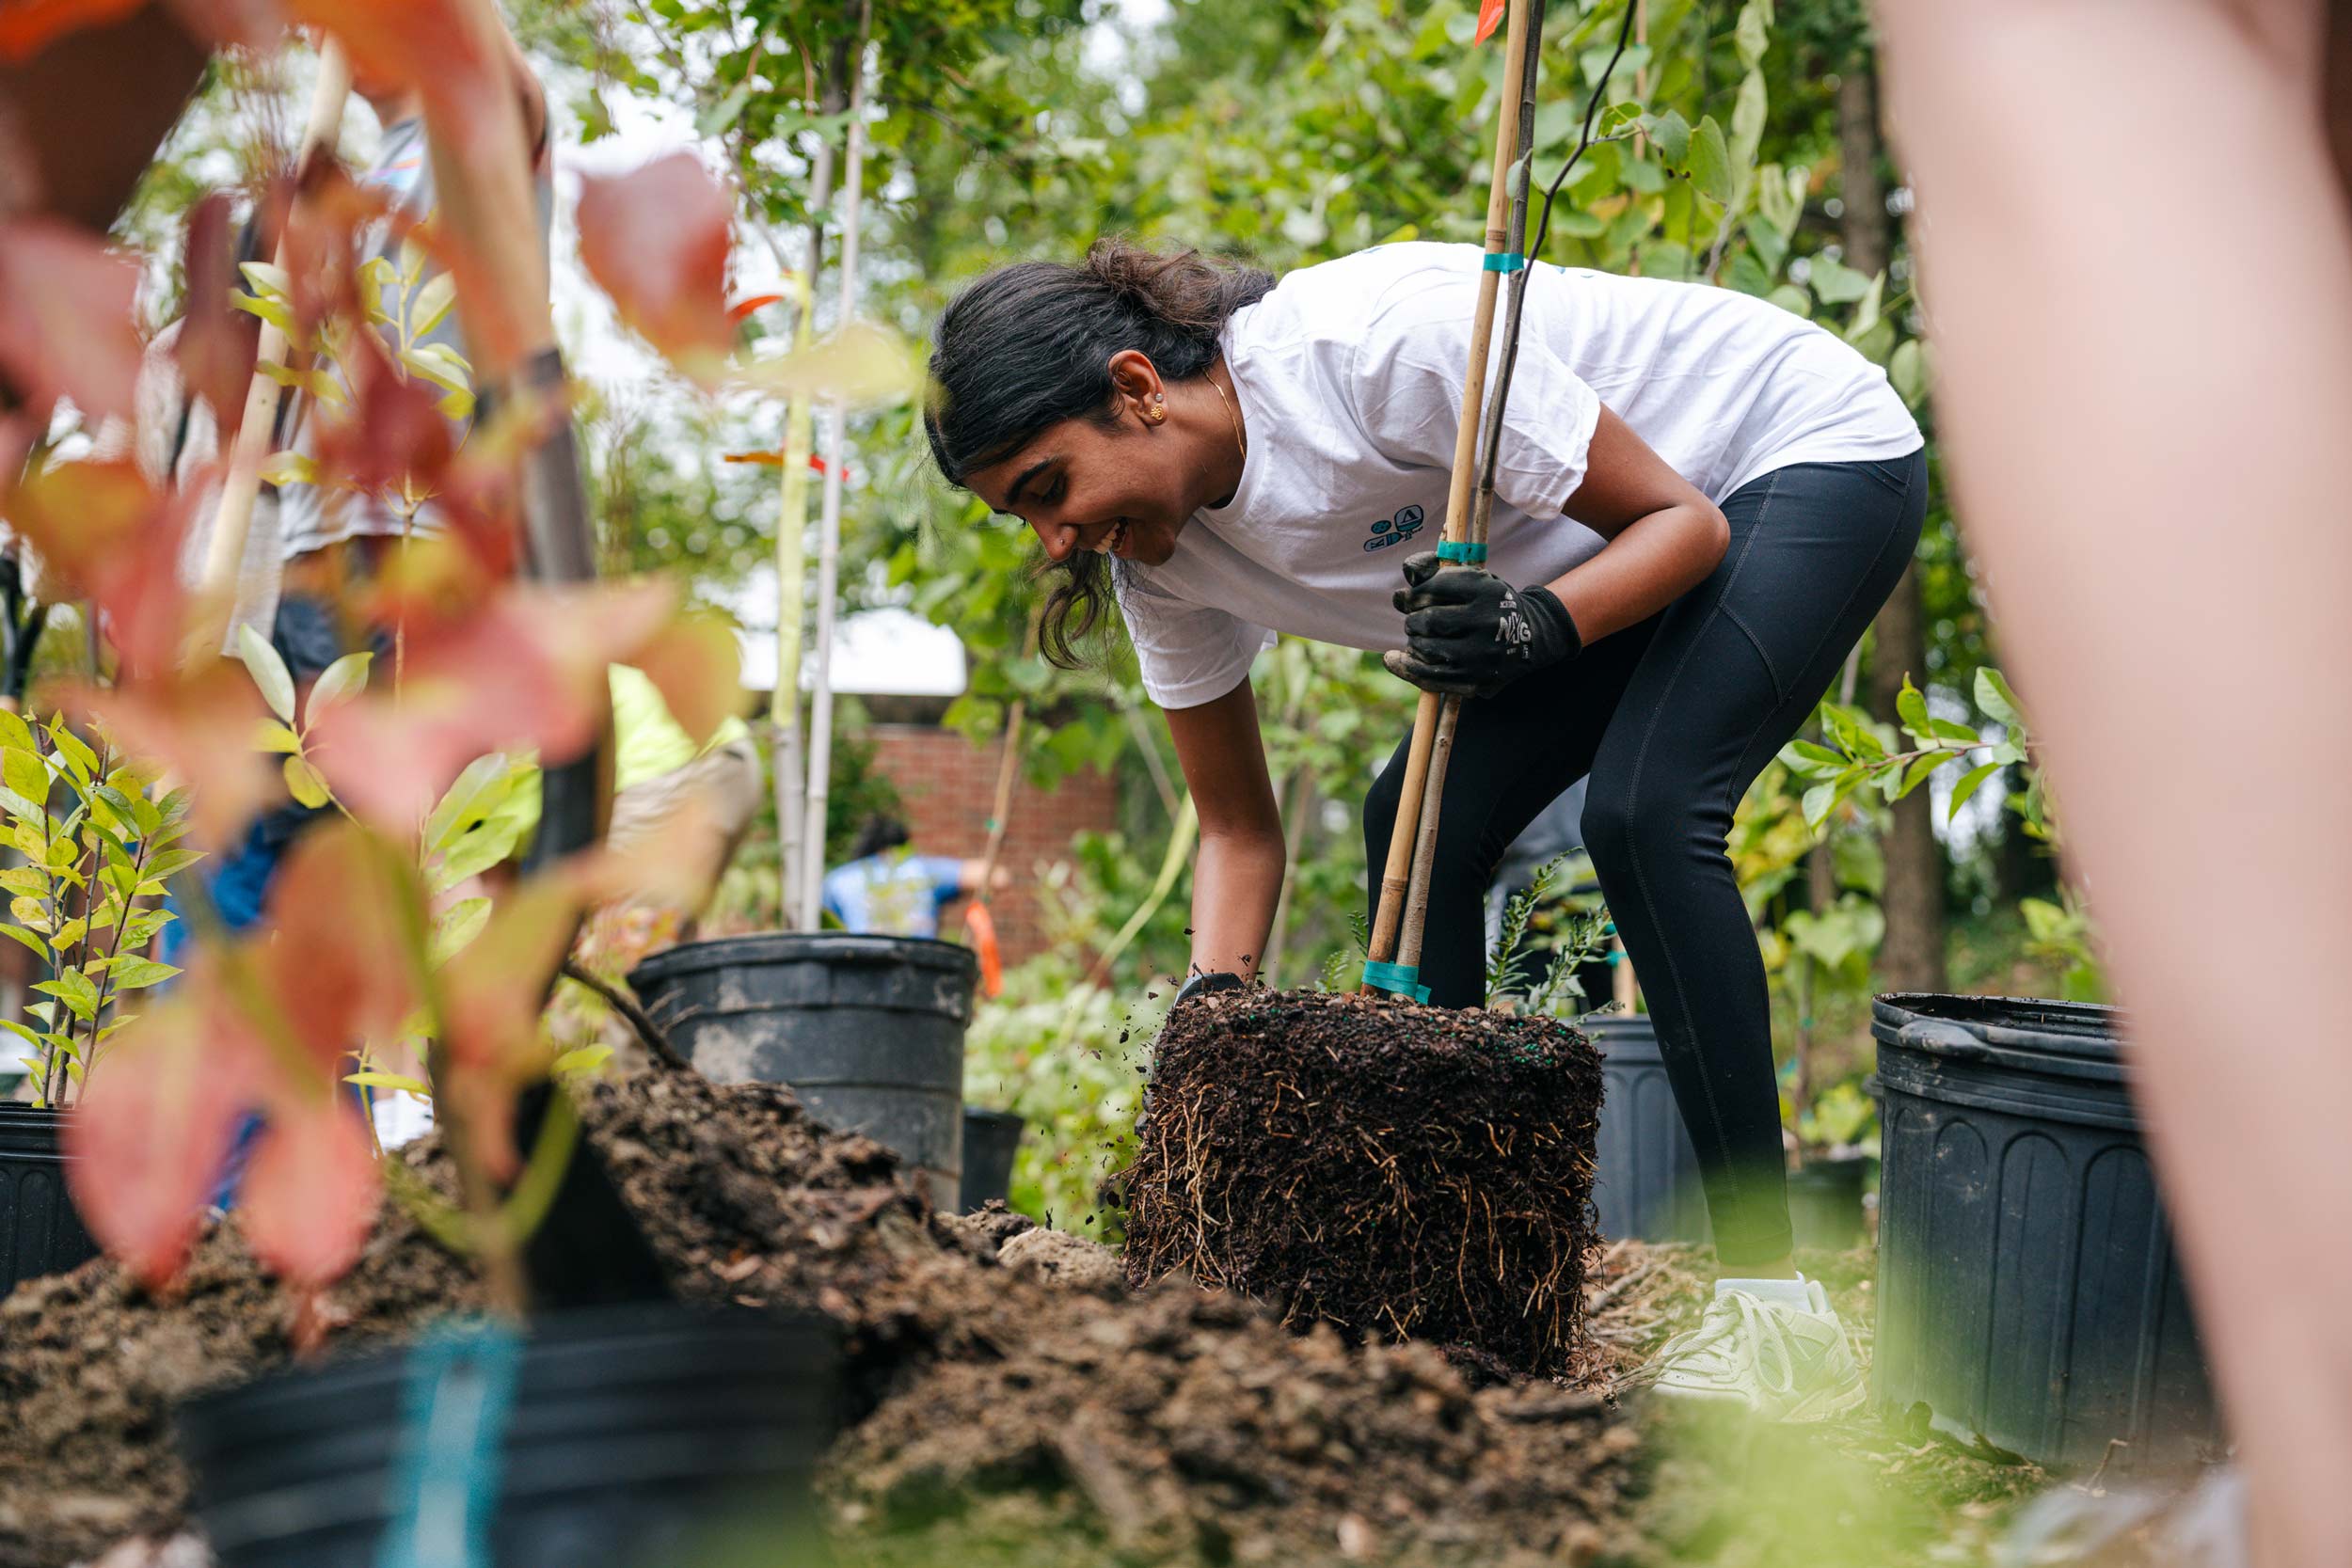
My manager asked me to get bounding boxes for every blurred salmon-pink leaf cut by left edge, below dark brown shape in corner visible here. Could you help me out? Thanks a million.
[0,218,139,423]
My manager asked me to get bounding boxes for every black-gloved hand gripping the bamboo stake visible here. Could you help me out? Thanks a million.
[1381,550,1585,696]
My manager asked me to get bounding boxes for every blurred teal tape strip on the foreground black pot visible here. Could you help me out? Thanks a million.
[376,1323,522,1568]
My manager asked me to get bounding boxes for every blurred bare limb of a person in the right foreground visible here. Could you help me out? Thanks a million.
[1877,0,2352,1568]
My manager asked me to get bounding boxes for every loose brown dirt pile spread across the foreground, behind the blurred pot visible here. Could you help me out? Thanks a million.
[0,1072,1632,1568]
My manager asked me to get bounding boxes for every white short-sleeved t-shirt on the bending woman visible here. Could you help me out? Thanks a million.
[1110,245,1919,707]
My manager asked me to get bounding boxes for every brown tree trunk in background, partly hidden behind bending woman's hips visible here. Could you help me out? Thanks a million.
[1837,56,1946,992]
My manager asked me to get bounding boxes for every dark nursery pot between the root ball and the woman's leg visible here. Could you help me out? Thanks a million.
[1576,1013,1708,1242]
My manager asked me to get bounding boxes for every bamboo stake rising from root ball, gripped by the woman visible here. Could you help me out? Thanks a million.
[1364,0,1543,990]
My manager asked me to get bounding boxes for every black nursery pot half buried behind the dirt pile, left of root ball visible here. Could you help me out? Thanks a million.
[628,931,981,1211]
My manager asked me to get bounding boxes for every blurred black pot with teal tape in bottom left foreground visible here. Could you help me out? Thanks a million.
[177,1303,840,1568]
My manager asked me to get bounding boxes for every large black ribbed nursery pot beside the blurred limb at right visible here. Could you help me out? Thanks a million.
[1870,994,2225,1472]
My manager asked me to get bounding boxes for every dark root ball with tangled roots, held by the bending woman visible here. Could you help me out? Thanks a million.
[1127,992,1602,1375]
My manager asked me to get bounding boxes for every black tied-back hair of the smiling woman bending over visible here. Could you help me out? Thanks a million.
[922,237,1275,670]
